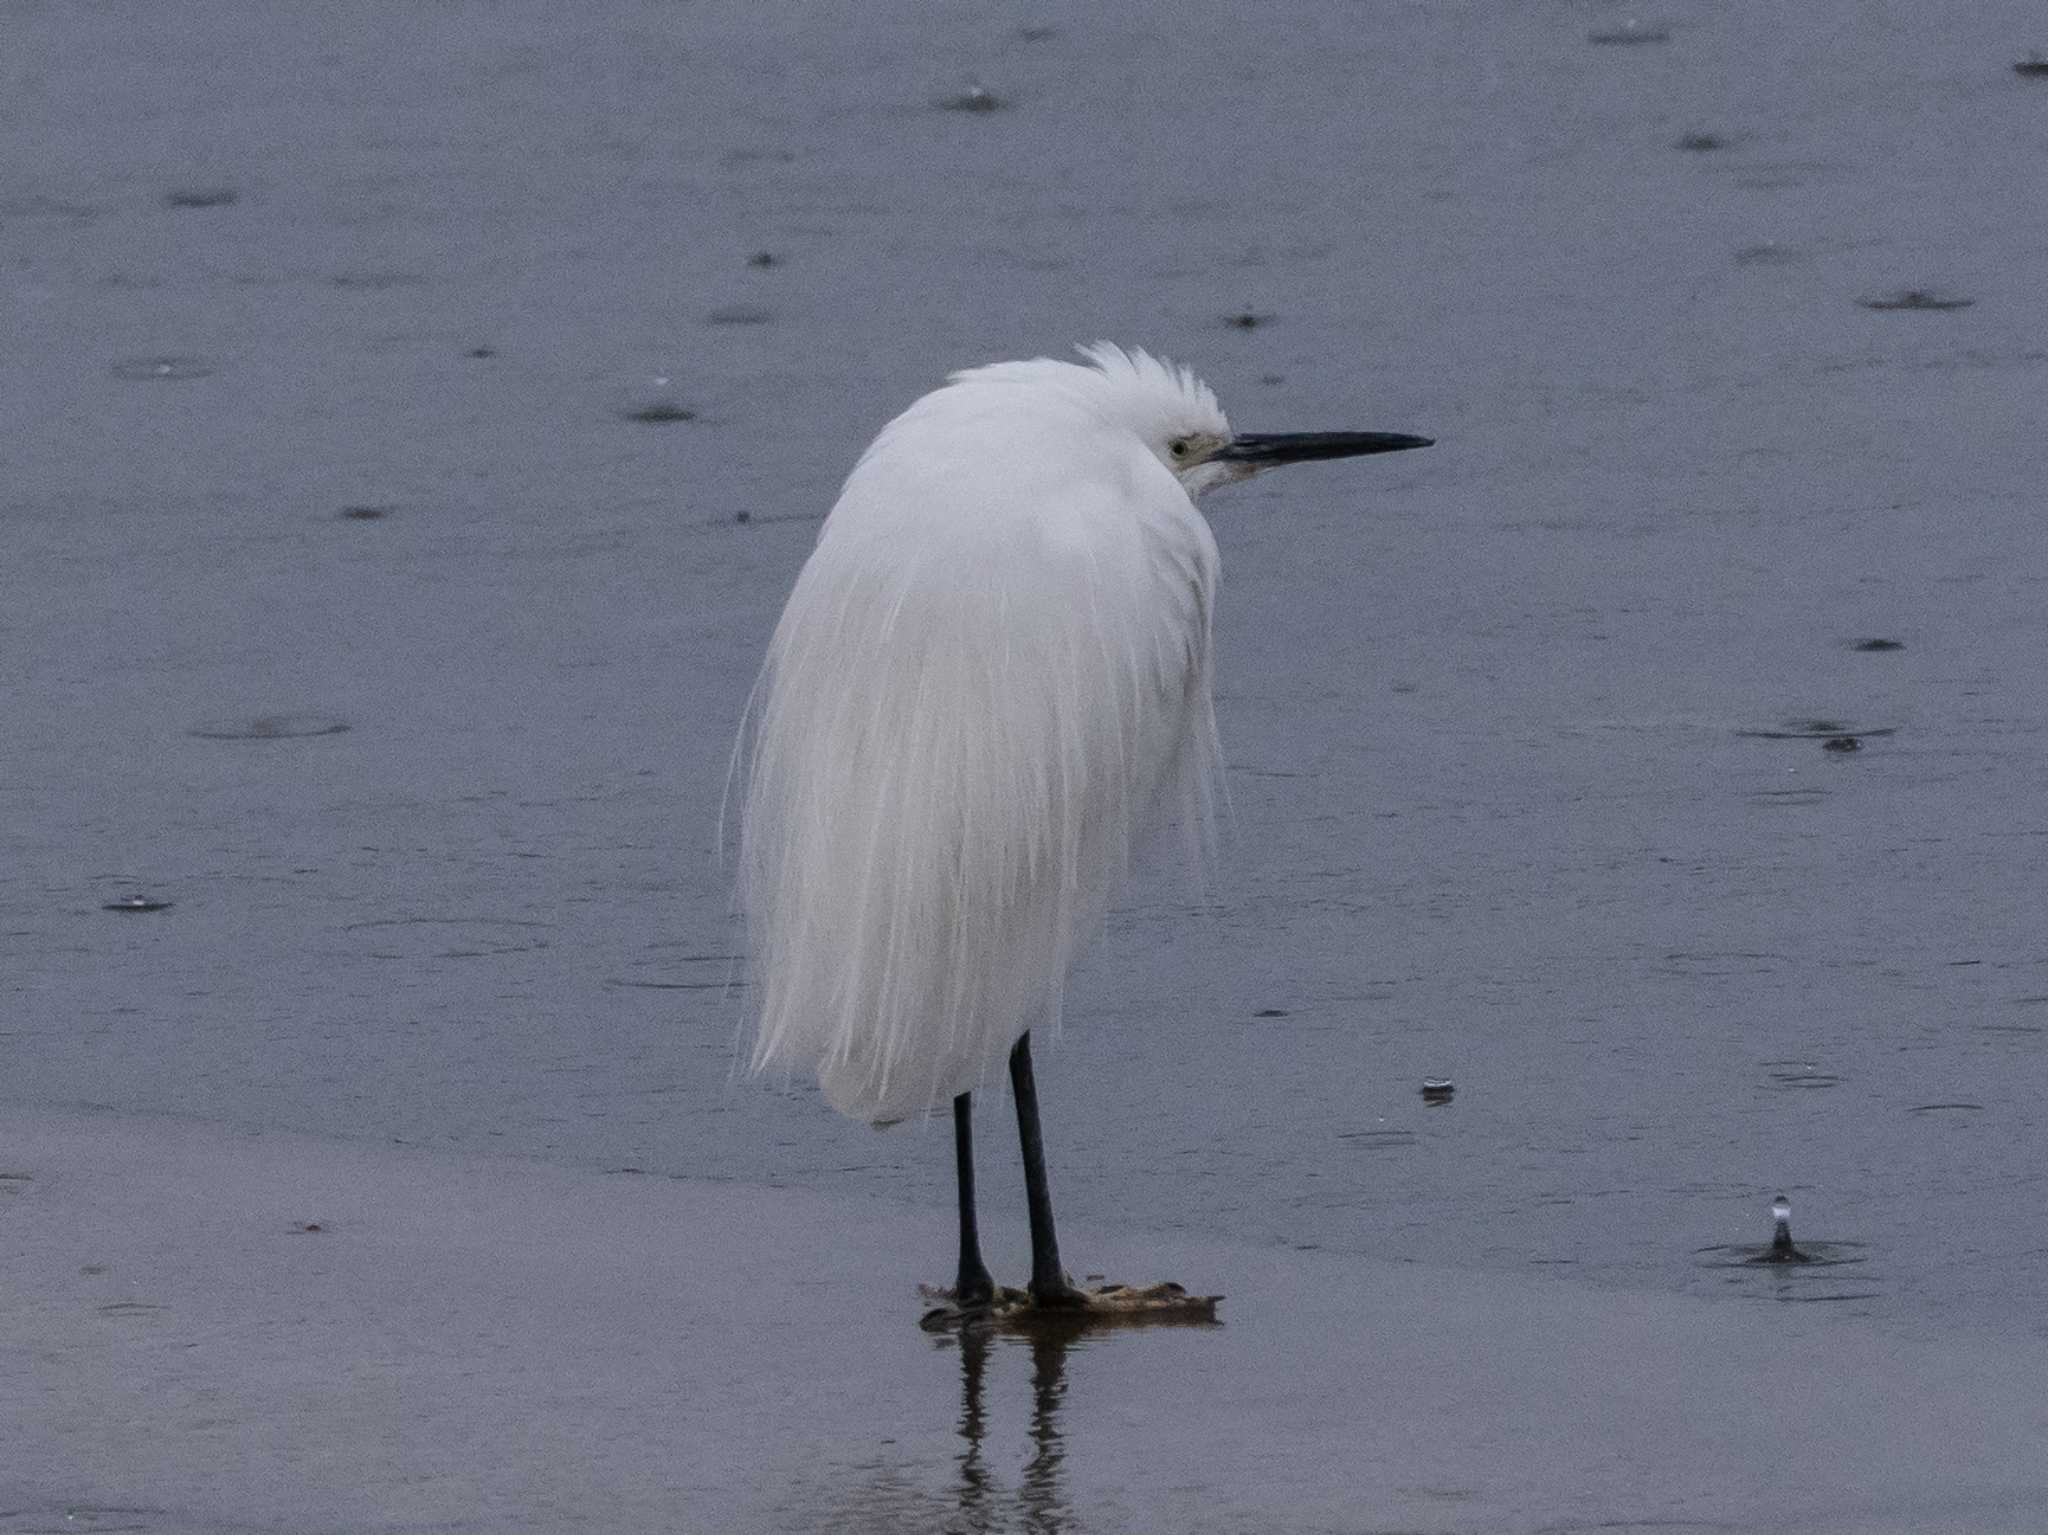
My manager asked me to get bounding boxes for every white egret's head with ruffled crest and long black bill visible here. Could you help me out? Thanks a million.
[1081,342,1432,497]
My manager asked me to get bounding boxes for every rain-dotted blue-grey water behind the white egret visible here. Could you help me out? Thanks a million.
[0,0,2048,1332]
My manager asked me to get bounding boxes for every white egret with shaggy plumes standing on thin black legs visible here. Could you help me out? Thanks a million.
[739,342,1430,1306]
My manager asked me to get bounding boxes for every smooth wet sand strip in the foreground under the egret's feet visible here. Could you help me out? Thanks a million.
[12,1115,2048,1535]
